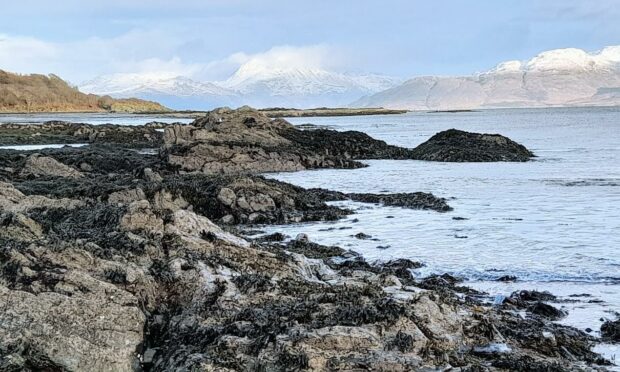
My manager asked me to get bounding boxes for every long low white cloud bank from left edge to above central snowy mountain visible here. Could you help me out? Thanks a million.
[0,30,344,83]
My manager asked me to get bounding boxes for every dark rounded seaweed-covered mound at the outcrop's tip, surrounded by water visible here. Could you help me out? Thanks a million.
[412,129,534,162]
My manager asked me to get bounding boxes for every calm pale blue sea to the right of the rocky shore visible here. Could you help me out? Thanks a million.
[262,108,620,358]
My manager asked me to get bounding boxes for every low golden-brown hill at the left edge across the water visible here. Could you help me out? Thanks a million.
[0,70,168,112]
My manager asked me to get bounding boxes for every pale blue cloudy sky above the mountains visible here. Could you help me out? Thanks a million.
[0,0,620,84]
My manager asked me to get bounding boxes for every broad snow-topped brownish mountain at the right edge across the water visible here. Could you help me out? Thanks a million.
[351,46,620,110]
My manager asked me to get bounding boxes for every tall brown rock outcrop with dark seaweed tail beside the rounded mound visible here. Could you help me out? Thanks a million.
[164,107,410,174]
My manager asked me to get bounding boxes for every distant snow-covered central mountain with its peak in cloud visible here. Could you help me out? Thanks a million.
[80,66,400,109]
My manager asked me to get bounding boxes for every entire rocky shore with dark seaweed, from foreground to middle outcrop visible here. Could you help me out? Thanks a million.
[0,109,613,371]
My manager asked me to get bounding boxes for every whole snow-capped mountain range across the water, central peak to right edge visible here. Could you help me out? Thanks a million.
[79,46,620,110]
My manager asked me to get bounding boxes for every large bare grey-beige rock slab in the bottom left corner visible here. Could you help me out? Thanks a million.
[0,276,144,371]
